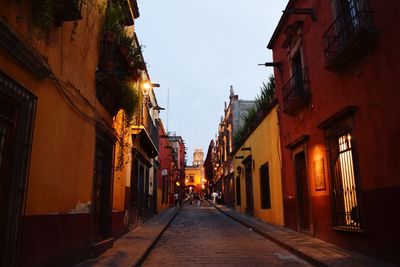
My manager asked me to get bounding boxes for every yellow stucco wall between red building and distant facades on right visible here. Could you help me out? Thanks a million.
[234,108,284,225]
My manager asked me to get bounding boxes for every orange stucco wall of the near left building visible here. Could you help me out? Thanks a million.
[0,0,129,215]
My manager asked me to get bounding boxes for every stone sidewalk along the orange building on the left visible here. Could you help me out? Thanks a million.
[76,207,180,267]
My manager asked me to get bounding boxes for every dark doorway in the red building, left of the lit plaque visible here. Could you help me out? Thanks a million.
[294,151,311,231]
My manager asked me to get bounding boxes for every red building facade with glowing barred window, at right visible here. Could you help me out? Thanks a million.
[268,0,400,264]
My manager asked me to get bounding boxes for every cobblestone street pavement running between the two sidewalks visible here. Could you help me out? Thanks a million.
[143,205,310,267]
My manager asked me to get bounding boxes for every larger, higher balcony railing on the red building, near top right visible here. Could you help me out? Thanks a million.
[322,0,377,71]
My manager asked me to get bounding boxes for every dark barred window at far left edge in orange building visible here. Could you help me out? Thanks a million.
[0,72,37,266]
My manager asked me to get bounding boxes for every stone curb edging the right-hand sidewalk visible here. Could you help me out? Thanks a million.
[214,206,329,267]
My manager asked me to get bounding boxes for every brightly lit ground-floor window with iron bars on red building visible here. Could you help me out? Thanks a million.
[326,117,361,230]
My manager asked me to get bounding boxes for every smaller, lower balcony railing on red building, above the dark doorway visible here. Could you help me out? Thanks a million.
[283,69,309,116]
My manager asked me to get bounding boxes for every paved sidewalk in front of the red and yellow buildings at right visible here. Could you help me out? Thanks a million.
[214,203,394,267]
